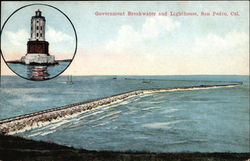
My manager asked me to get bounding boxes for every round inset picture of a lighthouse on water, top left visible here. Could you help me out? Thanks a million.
[1,4,77,81]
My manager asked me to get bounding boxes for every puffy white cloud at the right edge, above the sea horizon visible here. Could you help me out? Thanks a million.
[189,31,249,75]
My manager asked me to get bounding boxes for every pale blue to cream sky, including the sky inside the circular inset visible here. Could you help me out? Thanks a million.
[1,1,249,75]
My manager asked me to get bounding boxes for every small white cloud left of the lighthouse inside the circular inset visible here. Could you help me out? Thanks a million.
[4,29,29,47]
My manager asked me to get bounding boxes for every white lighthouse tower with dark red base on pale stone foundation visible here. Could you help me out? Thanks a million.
[21,9,57,65]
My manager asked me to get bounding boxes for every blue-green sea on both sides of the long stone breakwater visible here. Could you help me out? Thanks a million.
[0,76,249,152]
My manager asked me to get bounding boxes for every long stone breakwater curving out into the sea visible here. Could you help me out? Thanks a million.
[0,83,242,134]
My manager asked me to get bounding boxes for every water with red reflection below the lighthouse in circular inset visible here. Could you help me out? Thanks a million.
[8,62,70,80]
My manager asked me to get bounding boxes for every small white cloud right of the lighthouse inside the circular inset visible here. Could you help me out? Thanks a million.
[46,26,74,43]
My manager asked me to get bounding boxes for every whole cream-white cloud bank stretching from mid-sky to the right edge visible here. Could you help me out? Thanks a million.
[76,17,249,75]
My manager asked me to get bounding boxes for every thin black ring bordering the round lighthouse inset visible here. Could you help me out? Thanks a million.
[0,3,77,81]
